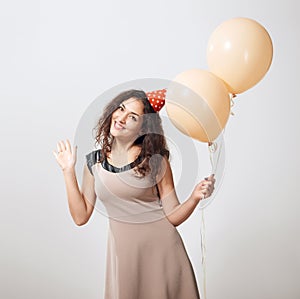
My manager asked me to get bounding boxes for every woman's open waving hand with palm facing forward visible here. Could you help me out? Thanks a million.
[53,139,77,171]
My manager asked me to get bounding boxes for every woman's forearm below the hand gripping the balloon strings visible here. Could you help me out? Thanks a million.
[167,196,200,226]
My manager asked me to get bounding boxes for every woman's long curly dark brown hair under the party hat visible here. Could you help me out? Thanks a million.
[94,89,169,181]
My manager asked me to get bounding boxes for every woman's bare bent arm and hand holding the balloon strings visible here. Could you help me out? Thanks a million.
[157,159,215,226]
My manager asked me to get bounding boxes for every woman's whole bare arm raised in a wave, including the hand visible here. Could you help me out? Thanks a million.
[53,140,96,225]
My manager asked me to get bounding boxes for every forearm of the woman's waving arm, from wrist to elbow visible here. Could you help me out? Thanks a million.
[63,168,87,225]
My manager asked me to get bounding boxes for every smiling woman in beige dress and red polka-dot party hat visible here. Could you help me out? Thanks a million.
[53,90,215,299]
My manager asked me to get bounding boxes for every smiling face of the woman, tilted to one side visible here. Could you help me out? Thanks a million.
[110,98,144,140]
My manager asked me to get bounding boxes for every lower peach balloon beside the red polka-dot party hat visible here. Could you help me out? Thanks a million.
[166,69,230,142]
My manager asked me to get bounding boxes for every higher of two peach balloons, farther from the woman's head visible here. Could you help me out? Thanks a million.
[207,18,273,94]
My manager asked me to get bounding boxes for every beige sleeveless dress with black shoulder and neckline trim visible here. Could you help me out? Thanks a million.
[86,150,200,299]
